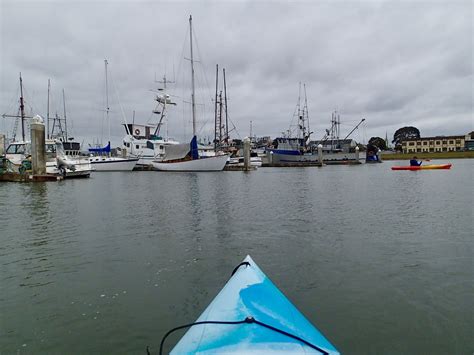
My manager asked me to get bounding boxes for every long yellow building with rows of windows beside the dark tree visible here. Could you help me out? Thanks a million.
[401,135,464,153]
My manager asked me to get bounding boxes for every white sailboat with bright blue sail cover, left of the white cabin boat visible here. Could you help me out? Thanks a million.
[89,59,139,171]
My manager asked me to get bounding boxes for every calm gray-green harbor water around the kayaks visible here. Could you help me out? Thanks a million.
[0,159,474,354]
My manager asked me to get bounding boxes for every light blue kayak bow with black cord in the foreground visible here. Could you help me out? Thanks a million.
[165,256,339,354]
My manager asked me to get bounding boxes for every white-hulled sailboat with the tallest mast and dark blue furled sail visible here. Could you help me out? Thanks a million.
[152,16,228,171]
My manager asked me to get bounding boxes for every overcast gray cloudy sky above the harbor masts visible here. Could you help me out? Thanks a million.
[0,0,473,144]
